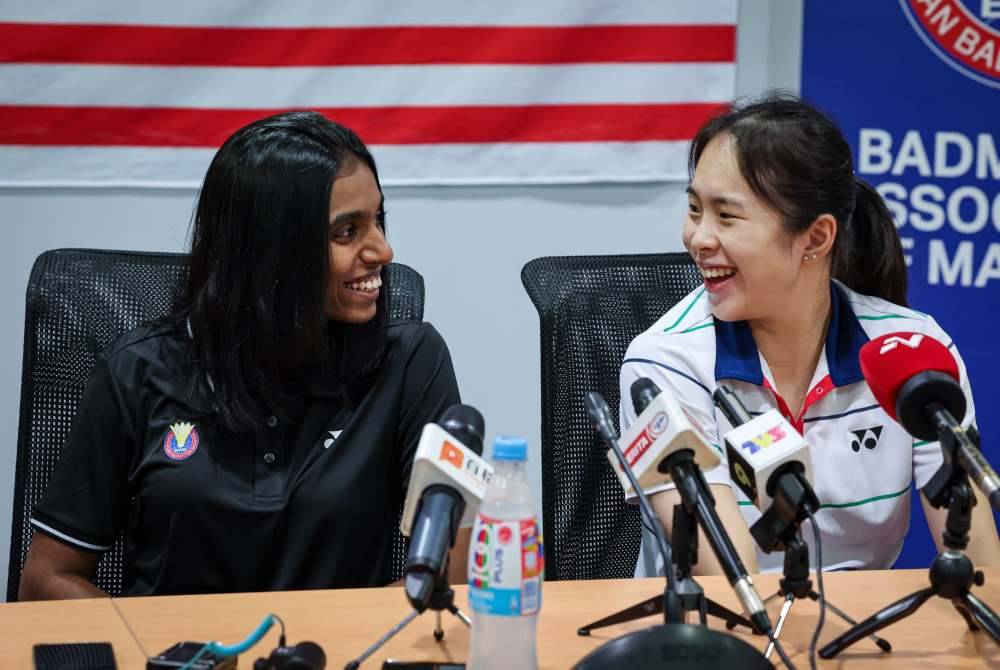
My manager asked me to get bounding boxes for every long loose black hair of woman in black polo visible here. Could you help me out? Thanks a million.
[172,112,389,432]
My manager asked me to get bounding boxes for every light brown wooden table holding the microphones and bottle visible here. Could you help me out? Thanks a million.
[0,569,1000,670]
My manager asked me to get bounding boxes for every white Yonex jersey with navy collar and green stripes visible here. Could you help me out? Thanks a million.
[620,281,975,576]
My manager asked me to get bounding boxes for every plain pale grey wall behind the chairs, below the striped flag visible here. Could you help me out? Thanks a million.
[0,0,802,594]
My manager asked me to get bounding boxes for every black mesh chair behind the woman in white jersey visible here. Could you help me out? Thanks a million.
[521,253,702,580]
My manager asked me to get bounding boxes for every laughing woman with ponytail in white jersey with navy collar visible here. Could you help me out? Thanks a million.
[621,96,1000,576]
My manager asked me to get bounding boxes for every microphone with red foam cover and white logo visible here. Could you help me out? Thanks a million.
[859,333,1000,511]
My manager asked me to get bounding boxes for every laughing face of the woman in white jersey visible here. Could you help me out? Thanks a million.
[683,134,807,321]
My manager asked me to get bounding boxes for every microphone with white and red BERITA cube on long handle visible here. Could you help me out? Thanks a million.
[623,377,771,633]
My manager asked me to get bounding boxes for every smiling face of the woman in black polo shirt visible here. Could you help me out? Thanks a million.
[325,160,392,323]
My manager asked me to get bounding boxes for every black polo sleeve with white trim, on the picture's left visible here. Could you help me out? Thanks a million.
[31,354,134,551]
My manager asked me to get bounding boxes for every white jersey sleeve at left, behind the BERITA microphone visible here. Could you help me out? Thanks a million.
[618,335,732,500]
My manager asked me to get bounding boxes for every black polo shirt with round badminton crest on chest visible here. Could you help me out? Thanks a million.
[32,322,459,595]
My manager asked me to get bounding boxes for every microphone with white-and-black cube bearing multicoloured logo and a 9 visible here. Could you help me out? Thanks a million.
[712,385,819,553]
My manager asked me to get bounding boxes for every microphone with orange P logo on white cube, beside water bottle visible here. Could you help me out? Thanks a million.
[399,405,493,612]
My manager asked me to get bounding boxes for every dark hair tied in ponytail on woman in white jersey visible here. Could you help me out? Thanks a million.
[688,93,907,305]
